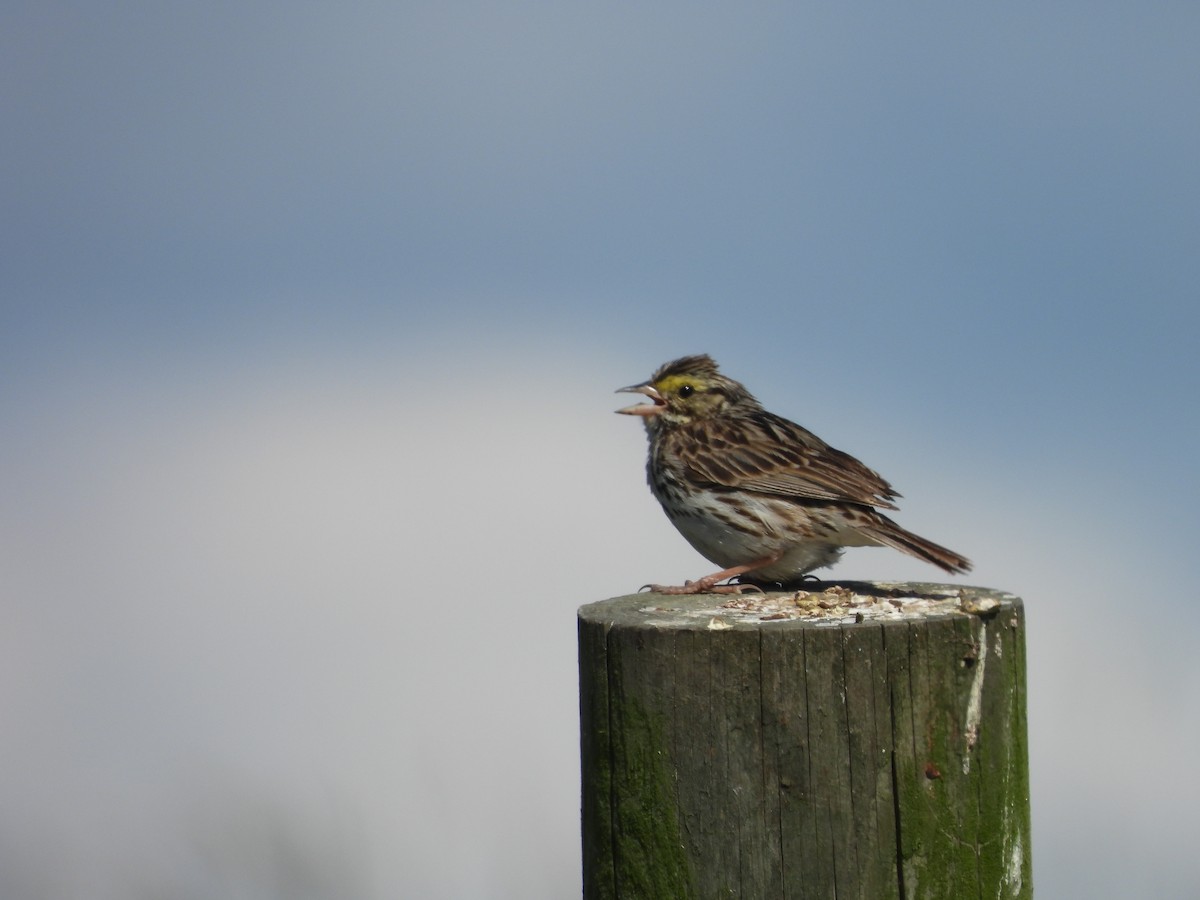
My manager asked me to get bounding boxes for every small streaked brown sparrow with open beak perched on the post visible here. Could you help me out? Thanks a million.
[616,354,971,594]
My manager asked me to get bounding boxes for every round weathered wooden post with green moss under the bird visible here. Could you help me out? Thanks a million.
[578,582,1033,900]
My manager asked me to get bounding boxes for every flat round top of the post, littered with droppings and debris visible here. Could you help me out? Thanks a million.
[578,581,1021,631]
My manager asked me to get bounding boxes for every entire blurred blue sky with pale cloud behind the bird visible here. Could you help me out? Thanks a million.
[0,2,1200,898]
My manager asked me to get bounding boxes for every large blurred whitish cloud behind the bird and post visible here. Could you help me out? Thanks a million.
[0,348,1200,898]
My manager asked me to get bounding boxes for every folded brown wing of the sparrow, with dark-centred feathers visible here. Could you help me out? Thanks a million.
[685,413,899,509]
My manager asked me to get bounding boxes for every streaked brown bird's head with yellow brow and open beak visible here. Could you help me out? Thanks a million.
[617,355,758,428]
